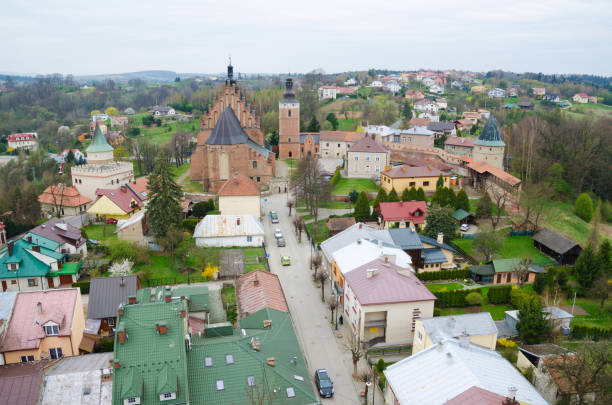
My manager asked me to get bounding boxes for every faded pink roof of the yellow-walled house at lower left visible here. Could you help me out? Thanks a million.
[1,288,82,352]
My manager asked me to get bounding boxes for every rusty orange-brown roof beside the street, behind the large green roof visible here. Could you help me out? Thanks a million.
[236,270,289,319]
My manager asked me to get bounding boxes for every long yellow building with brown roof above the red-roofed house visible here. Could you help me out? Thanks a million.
[380,166,450,195]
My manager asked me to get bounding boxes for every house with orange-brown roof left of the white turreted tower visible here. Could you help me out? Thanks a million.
[38,183,91,216]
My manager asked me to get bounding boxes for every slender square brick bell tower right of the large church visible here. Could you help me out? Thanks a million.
[278,78,300,159]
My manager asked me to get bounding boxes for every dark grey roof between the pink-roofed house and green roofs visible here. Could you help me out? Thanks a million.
[87,275,138,319]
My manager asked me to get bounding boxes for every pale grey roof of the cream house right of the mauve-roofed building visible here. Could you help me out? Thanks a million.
[423,312,497,343]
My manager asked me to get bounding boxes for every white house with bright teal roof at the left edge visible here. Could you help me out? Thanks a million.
[0,235,69,291]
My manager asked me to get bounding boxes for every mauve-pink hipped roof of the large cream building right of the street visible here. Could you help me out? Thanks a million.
[344,259,436,305]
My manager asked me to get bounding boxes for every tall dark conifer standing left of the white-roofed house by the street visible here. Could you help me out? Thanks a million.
[147,153,183,237]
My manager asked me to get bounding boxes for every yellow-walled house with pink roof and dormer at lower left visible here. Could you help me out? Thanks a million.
[0,288,85,364]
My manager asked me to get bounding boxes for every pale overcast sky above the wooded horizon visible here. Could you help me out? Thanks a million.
[0,0,612,75]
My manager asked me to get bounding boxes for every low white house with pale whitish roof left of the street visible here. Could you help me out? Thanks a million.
[193,214,264,247]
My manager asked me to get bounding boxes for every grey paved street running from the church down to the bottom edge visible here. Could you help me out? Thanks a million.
[264,194,362,404]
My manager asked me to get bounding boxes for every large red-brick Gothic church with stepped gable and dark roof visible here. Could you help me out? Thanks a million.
[191,64,276,192]
